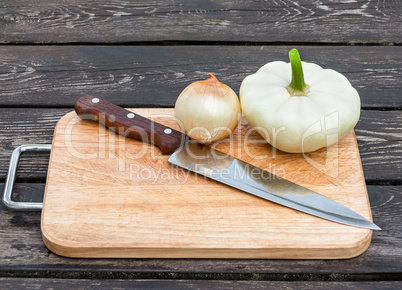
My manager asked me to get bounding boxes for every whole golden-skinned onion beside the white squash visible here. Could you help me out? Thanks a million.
[175,74,241,143]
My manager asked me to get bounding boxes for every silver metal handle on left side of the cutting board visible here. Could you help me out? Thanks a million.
[3,144,52,211]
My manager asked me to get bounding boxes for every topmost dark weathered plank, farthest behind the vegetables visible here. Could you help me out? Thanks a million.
[0,0,402,43]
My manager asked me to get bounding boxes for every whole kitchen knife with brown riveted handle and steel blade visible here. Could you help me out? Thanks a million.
[75,95,380,230]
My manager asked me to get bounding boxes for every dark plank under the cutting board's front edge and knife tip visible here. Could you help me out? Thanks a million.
[0,184,402,281]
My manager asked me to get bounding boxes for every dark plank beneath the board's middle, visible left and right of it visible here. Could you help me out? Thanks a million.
[0,108,402,184]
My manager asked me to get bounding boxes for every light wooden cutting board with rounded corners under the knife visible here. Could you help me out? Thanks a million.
[41,109,372,259]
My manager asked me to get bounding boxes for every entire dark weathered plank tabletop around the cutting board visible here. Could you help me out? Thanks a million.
[0,0,402,289]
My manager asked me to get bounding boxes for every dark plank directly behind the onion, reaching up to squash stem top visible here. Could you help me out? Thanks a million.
[0,46,402,109]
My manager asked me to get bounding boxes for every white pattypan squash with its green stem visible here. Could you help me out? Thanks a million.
[240,49,360,153]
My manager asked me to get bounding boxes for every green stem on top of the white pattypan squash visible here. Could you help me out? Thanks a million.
[286,49,310,97]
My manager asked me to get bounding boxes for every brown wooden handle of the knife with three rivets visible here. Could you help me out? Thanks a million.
[75,95,186,154]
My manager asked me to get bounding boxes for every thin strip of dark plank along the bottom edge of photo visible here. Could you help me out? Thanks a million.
[0,278,402,290]
